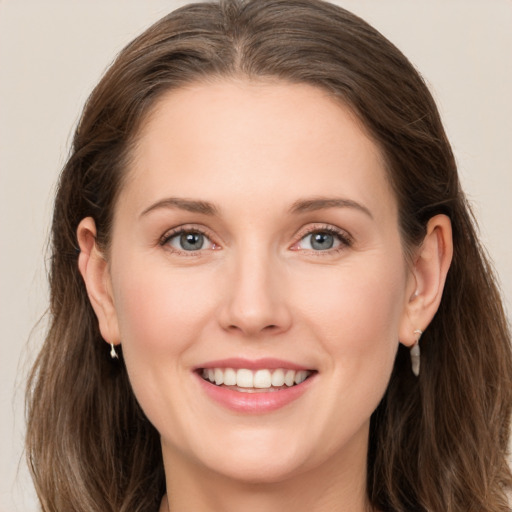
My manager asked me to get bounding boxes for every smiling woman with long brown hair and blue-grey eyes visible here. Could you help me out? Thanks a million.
[27,0,512,512]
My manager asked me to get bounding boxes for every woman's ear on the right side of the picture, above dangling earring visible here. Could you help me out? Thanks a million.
[399,215,453,347]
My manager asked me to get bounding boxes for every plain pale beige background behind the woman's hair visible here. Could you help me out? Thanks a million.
[0,0,512,512]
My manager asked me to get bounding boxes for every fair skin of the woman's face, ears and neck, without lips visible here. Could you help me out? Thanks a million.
[78,80,451,512]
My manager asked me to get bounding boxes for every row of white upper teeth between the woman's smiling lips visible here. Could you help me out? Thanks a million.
[199,368,314,393]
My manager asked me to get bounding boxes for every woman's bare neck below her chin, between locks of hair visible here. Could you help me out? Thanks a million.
[160,438,372,512]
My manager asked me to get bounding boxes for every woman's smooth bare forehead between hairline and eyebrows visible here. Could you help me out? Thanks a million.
[122,80,395,220]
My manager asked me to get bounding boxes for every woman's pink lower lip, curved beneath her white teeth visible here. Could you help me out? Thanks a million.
[196,374,316,414]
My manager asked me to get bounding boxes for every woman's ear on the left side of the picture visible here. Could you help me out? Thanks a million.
[77,217,120,345]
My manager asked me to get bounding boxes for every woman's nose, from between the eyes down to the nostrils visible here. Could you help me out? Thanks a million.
[219,247,292,338]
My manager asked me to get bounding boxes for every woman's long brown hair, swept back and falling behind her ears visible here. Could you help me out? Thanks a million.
[27,0,512,512]
